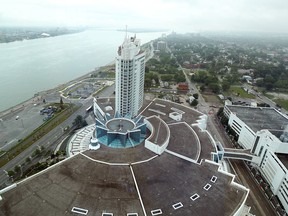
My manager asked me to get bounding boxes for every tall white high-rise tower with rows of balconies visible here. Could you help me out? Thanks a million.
[115,36,145,117]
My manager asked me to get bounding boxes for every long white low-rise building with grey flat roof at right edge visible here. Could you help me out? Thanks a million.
[224,105,288,212]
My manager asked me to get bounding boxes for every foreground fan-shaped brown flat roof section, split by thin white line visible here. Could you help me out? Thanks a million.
[0,148,247,216]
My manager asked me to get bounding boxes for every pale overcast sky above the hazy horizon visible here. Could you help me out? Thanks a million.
[0,0,288,33]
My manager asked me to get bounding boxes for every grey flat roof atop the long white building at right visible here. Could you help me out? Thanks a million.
[227,105,288,133]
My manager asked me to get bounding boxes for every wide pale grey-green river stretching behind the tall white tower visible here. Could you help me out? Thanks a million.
[0,30,162,111]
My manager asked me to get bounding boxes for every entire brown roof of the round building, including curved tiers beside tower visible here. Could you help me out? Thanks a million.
[0,99,248,216]
